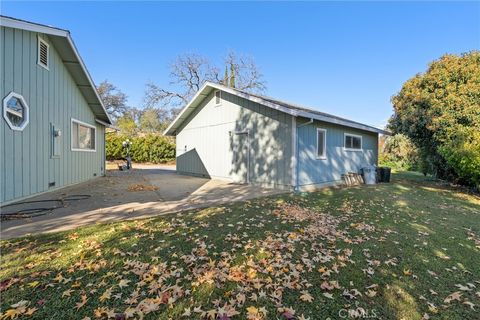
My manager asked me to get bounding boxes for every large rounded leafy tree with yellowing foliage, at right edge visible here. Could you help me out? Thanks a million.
[390,51,480,188]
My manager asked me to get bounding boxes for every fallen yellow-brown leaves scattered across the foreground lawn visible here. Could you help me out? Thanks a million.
[2,190,479,320]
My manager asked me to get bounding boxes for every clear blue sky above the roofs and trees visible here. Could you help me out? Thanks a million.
[1,1,480,126]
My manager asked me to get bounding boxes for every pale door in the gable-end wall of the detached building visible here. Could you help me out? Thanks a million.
[232,131,250,184]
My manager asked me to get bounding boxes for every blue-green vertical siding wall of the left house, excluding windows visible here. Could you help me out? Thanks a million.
[0,27,105,202]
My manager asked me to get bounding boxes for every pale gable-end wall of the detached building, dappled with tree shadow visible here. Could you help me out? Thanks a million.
[176,92,292,188]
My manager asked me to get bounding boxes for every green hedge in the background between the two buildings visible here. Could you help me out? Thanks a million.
[105,133,175,163]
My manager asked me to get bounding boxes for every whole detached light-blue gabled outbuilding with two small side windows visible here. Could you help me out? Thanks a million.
[165,82,388,190]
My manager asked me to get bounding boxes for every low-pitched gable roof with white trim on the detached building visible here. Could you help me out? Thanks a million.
[164,81,390,136]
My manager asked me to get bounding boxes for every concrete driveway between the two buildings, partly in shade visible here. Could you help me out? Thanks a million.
[1,165,282,239]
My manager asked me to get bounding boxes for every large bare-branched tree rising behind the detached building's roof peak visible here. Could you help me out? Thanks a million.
[143,52,266,118]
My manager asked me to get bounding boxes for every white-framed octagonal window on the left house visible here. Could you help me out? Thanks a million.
[3,92,28,131]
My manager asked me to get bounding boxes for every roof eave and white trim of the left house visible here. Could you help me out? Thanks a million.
[0,15,112,125]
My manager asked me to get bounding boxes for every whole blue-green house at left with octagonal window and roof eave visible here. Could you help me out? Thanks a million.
[0,16,111,204]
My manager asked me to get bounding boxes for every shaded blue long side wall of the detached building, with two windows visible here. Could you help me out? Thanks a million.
[297,120,378,187]
